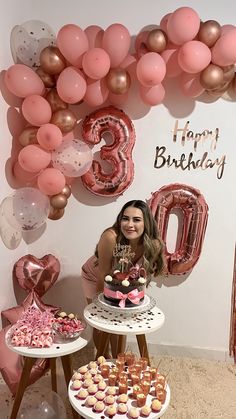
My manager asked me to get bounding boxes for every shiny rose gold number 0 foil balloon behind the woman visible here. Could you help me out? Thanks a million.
[149,183,208,275]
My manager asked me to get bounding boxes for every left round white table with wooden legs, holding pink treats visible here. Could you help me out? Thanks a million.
[6,329,88,419]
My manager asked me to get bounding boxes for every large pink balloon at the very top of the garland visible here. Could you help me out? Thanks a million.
[167,7,200,45]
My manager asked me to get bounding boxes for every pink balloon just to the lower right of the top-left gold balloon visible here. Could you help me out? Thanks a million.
[57,67,86,103]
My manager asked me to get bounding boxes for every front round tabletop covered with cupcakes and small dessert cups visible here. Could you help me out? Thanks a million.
[69,352,170,419]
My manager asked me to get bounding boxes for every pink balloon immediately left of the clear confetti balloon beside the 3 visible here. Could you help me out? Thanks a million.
[18,144,51,173]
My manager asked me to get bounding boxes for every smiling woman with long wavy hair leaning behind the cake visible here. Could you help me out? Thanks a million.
[82,200,164,358]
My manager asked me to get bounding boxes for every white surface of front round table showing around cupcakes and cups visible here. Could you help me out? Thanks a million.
[68,361,170,419]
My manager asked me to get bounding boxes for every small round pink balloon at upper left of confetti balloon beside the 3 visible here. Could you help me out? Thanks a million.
[37,124,62,151]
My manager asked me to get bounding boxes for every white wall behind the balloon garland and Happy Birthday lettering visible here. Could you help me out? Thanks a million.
[0,0,236,360]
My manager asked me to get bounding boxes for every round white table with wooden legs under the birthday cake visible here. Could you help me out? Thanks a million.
[84,294,165,365]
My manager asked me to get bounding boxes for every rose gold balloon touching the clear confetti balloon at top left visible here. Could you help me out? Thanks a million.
[40,46,66,74]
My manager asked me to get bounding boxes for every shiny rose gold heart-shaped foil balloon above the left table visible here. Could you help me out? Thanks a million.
[13,254,60,297]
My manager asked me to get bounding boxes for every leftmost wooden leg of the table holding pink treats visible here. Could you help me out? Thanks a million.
[10,357,37,419]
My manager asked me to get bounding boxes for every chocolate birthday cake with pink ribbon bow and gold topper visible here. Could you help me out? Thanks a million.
[103,245,147,308]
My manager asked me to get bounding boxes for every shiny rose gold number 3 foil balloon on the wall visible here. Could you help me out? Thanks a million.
[81,106,135,196]
